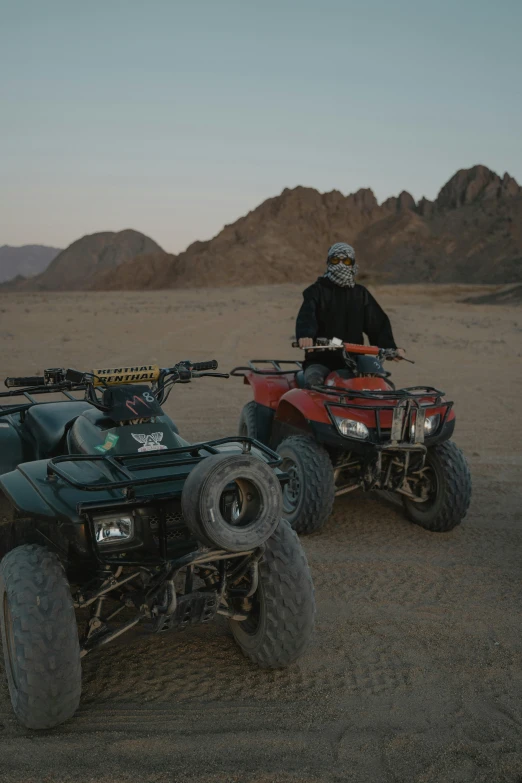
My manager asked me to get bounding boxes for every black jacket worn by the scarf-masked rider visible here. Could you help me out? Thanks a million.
[295,277,397,369]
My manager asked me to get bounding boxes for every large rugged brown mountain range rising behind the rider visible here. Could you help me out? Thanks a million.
[93,166,522,290]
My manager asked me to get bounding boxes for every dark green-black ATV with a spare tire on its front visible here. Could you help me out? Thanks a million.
[0,362,315,729]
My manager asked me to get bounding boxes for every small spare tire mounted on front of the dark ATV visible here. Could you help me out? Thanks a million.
[181,454,283,552]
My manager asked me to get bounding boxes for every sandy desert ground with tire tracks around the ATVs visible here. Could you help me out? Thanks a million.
[0,286,522,783]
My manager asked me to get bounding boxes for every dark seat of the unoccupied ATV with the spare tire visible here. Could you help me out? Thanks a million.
[25,400,90,459]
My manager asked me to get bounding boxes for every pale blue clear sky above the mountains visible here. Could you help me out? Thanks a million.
[0,0,522,252]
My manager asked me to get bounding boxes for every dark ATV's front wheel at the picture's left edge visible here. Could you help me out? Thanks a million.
[0,544,82,729]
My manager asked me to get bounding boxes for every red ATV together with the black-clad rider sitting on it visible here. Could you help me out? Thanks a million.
[232,242,471,533]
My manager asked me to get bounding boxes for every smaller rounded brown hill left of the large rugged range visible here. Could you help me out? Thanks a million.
[5,229,163,291]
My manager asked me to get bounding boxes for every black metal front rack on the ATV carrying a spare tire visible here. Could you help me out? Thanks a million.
[47,435,282,498]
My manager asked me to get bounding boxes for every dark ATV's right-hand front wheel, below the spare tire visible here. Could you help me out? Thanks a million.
[230,519,315,669]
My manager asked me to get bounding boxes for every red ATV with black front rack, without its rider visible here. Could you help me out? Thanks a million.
[232,339,471,533]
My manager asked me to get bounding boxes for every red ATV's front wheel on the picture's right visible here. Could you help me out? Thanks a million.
[403,440,471,533]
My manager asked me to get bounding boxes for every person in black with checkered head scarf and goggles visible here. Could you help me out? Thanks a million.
[296,242,405,388]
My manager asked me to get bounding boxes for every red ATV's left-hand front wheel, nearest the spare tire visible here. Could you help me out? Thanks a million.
[277,435,335,533]
